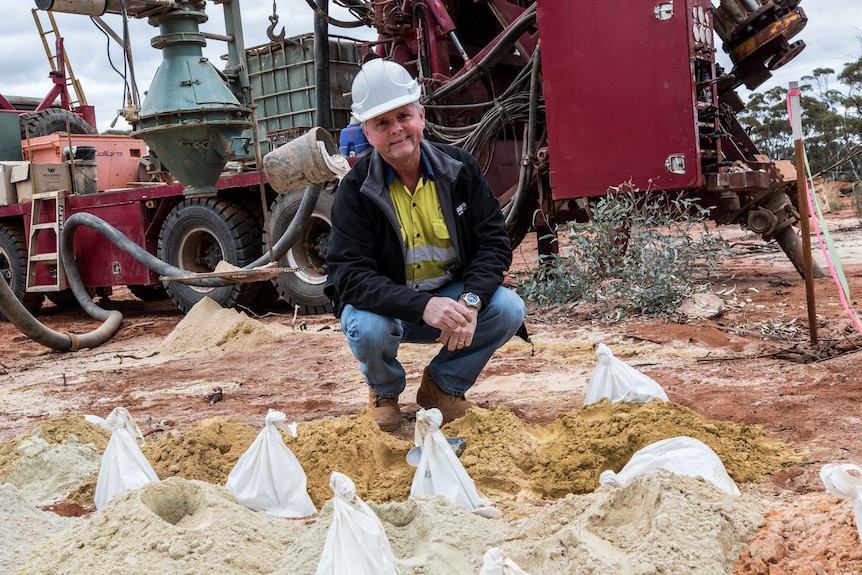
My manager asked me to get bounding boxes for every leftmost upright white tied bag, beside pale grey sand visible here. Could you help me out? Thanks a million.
[94,407,159,509]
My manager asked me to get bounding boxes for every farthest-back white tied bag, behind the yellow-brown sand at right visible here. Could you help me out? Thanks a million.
[584,343,668,405]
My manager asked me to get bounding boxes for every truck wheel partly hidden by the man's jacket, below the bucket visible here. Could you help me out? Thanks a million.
[264,189,332,315]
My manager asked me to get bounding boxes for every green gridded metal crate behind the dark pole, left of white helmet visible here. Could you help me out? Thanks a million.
[246,34,362,154]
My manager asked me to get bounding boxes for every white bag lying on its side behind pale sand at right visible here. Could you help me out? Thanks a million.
[599,436,739,495]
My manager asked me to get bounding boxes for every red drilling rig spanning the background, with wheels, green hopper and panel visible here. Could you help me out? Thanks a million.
[0,0,816,342]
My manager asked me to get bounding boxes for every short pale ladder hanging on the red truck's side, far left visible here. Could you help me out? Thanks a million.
[27,190,66,293]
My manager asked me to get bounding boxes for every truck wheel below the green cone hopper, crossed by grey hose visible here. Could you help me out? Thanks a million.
[158,198,260,313]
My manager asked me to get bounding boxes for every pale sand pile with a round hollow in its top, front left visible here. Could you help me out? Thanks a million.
[15,477,305,575]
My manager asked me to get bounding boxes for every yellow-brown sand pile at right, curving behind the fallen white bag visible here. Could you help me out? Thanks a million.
[447,399,801,500]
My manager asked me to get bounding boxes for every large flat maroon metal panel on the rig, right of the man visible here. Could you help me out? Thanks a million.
[538,0,717,200]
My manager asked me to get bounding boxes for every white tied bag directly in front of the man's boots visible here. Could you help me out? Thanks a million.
[410,409,497,517]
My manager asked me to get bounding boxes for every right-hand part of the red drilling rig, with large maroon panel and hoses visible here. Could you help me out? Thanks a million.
[330,0,807,273]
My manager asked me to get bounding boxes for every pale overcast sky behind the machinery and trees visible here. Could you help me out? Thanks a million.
[0,0,862,131]
